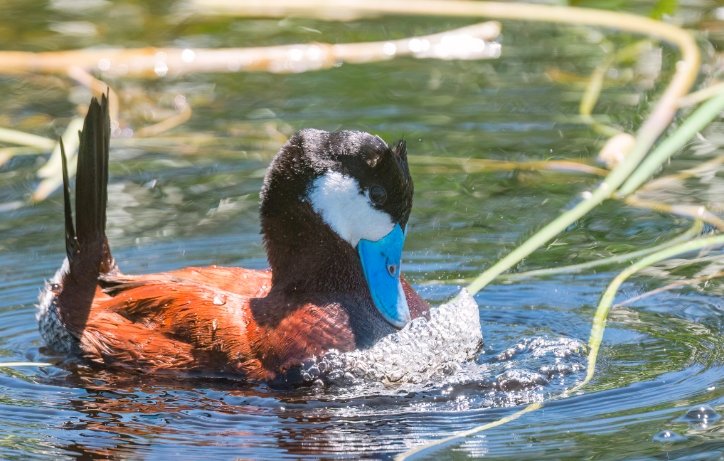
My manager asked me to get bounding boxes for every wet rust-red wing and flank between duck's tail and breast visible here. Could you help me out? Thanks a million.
[79,273,265,379]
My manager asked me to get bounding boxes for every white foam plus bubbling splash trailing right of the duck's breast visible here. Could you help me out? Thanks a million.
[301,290,586,408]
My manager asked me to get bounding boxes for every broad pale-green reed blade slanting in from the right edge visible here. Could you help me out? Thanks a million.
[616,89,724,197]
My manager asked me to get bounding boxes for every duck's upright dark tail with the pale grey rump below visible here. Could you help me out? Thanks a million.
[38,95,116,350]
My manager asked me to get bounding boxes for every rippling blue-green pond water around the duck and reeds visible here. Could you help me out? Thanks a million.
[0,1,724,460]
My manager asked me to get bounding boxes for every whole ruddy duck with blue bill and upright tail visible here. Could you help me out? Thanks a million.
[37,95,430,385]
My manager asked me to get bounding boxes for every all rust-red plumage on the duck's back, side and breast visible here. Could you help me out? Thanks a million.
[60,266,427,380]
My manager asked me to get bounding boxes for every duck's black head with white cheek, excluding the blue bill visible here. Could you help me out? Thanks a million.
[261,129,413,283]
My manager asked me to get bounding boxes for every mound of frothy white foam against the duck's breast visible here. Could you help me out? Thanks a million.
[302,290,483,386]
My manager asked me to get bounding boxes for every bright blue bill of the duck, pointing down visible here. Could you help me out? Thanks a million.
[357,224,410,328]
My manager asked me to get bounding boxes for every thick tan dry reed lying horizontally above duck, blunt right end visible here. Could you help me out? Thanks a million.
[0,22,500,78]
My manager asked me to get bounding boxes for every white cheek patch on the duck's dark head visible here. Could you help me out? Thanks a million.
[307,171,395,247]
